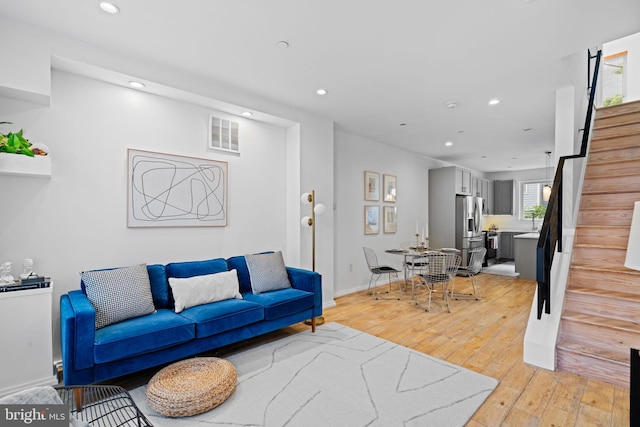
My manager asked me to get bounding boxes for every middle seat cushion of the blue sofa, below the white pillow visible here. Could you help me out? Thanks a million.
[180,299,264,338]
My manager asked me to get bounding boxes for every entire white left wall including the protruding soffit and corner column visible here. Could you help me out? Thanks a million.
[0,16,334,358]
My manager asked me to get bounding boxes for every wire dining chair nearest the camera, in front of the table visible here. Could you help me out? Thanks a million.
[412,252,462,313]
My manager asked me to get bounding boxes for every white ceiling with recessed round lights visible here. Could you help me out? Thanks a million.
[0,0,640,172]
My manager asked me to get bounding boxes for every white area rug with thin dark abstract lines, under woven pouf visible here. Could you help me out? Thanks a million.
[131,323,498,427]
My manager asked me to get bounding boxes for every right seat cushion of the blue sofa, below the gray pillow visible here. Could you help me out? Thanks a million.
[243,288,314,320]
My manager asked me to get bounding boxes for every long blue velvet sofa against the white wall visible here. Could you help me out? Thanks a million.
[60,256,322,385]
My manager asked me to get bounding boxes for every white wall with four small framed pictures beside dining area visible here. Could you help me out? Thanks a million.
[334,130,443,296]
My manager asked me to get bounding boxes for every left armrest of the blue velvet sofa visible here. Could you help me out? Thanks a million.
[60,290,96,370]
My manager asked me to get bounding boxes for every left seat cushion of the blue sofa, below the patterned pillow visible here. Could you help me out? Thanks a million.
[93,308,195,363]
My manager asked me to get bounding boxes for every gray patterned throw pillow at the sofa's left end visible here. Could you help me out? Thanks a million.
[81,264,155,329]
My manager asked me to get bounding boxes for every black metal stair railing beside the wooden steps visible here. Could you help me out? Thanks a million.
[536,50,602,319]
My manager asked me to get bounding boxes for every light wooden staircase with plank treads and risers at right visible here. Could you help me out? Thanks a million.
[556,101,640,387]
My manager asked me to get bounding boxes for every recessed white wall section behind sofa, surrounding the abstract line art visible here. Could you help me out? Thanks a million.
[0,72,296,358]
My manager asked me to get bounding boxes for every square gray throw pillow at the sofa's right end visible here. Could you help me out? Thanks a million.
[245,251,291,294]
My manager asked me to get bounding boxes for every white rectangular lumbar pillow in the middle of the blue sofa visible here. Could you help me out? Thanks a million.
[169,270,242,313]
